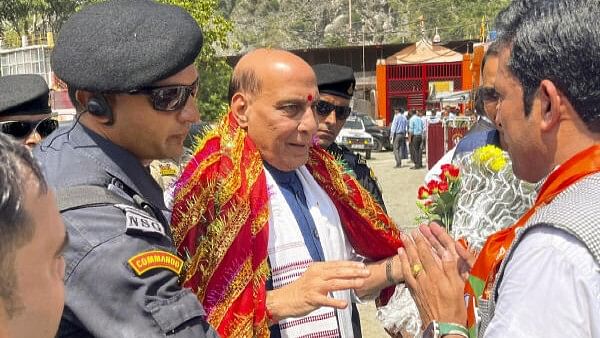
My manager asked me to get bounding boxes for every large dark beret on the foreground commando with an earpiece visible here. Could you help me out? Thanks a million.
[51,0,202,92]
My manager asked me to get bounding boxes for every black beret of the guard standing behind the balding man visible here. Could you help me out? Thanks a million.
[313,63,356,99]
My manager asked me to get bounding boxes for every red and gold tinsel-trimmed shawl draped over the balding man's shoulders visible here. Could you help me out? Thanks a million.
[171,113,402,337]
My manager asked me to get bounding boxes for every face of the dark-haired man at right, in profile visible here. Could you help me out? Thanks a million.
[495,48,547,182]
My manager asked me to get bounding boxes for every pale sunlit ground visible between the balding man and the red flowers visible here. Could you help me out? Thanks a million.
[358,152,427,338]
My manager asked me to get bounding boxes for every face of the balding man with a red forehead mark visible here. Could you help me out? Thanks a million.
[246,62,318,171]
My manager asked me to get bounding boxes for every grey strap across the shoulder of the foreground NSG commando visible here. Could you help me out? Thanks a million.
[56,185,131,213]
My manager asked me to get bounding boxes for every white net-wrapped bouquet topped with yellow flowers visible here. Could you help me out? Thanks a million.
[452,145,539,250]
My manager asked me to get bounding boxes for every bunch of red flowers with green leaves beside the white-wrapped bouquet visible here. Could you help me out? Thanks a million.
[417,164,460,232]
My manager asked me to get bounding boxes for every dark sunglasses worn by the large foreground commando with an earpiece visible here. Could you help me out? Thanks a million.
[129,79,198,111]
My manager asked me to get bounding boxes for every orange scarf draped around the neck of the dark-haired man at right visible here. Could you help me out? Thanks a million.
[465,145,600,337]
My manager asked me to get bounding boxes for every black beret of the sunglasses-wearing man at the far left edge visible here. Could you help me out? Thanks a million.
[0,74,52,116]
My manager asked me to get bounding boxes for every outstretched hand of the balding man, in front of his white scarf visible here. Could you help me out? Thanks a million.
[267,261,370,321]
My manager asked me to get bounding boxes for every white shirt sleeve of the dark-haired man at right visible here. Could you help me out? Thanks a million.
[485,227,600,338]
